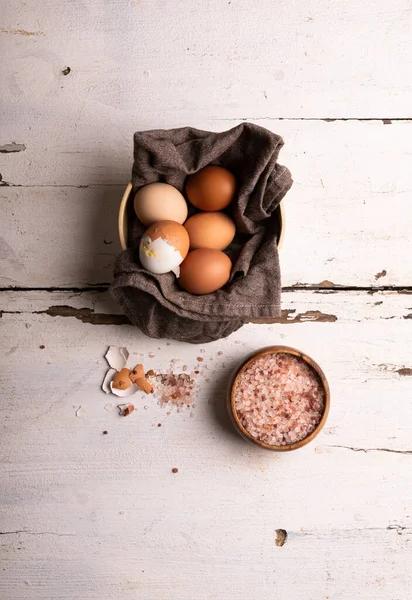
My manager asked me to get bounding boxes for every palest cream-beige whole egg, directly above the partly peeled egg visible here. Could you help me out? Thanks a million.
[134,183,187,225]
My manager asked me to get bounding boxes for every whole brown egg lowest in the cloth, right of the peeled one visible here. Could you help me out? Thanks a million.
[178,248,232,295]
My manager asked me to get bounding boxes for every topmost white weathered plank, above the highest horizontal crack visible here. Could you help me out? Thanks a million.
[0,0,412,142]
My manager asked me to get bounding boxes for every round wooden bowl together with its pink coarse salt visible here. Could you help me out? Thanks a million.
[228,346,330,452]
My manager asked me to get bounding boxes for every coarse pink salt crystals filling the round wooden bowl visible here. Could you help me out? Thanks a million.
[235,353,325,446]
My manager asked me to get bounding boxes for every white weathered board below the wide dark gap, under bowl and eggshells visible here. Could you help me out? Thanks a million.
[0,291,412,600]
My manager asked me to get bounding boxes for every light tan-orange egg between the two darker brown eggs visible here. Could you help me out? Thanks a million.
[184,212,236,250]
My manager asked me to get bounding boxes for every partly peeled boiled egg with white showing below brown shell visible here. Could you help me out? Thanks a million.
[139,221,189,275]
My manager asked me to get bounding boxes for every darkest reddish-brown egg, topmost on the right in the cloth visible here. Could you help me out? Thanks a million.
[186,165,236,211]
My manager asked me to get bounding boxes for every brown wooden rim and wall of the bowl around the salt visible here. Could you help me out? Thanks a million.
[227,346,330,452]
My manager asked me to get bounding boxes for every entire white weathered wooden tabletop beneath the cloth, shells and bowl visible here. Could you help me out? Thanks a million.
[0,0,412,600]
